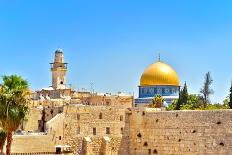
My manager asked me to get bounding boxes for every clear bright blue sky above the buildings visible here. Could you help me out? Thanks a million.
[0,0,232,102]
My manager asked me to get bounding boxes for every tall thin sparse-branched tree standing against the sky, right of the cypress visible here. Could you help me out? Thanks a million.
[200,72,213,108]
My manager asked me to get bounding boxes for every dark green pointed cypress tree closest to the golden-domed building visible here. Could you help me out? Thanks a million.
[175,82,188,110]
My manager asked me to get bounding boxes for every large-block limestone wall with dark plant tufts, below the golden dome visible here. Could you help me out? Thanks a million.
[127,108,232,155]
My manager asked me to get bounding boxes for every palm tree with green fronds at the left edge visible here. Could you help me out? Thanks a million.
[0,75,29,155]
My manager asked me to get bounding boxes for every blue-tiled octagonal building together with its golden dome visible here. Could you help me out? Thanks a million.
[135,59,180,105]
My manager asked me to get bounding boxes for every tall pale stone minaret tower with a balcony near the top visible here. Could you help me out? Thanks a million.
[50,49,67,89]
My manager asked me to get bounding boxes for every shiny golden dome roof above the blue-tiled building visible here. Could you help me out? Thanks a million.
[140,61,180,86]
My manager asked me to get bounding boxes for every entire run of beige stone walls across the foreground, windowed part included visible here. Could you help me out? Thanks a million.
[12,105,232,155]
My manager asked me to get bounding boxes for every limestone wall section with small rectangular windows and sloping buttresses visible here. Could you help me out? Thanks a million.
[64,105,126,155]
